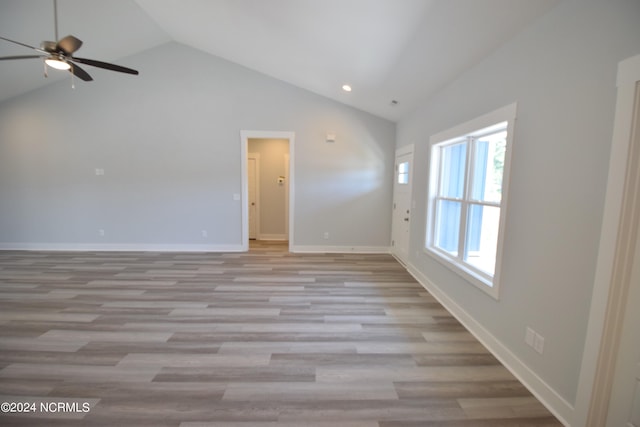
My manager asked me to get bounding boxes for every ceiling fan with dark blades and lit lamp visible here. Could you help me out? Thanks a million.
[0,0,138,82]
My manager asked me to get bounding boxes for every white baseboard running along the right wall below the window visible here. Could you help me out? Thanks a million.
[407,263,574,426]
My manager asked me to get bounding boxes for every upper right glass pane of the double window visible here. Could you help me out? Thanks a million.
[471,131,507,203]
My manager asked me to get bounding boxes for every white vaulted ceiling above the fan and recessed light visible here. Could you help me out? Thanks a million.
[0,0,560,120]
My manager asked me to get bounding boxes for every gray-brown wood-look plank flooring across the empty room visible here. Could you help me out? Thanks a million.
[0,243,560,427]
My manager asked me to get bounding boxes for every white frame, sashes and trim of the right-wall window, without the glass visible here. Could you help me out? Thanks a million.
[424,103,516,300]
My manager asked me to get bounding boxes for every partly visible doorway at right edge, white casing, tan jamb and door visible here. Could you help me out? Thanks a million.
[571,55,640,427]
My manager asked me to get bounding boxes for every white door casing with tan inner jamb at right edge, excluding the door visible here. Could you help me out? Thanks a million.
[572,55,640,427]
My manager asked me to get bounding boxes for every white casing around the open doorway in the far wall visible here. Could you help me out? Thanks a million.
[240,130,295,251]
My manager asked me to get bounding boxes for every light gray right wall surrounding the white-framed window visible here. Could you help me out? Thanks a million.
[397,0,640,418]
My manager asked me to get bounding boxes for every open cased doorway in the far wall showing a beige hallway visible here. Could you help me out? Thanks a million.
[240,131,294,251]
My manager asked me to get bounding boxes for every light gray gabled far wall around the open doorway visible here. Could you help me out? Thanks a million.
[0,43,395,250]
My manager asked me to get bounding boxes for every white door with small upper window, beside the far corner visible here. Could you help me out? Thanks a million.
[391,146,413,263]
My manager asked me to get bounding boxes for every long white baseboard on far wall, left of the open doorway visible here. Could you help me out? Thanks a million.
[0,243,243,252]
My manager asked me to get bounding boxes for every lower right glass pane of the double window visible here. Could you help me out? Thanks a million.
[464,204,500,276]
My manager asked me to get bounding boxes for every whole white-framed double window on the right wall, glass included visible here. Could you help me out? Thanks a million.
[425,104,515,298]
